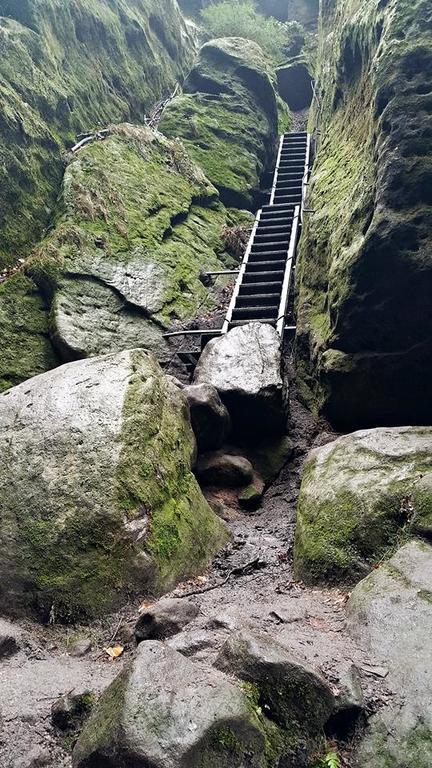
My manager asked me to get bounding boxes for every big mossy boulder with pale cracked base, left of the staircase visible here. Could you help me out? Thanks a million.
[26,125,245,360]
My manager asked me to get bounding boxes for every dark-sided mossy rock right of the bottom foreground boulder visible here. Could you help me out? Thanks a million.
[215,631,335,749]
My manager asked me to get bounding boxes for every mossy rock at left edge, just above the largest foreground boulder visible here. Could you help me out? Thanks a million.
[0,273,58,392]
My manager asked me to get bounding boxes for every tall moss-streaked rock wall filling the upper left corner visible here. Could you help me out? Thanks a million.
[0,0,194,264]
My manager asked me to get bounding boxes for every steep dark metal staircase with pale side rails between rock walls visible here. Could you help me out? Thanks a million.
[222,133,310,336]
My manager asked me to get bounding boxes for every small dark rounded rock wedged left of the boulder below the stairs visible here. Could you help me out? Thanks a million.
[183,384,231,453]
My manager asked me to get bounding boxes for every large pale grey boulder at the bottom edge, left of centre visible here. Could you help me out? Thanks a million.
[73,641,291,768]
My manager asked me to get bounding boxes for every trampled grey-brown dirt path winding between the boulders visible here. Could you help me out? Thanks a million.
[0,374,390,768]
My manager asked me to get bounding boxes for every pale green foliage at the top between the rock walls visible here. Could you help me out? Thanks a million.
[201,0,290,61]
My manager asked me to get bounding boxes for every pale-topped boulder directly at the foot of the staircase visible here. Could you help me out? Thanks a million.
[194,323,287,438]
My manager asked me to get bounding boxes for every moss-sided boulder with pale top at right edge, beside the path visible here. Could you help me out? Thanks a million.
[295,427,432,582]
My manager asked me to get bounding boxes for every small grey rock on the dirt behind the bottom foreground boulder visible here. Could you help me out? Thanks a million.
[135,598,199,643]
